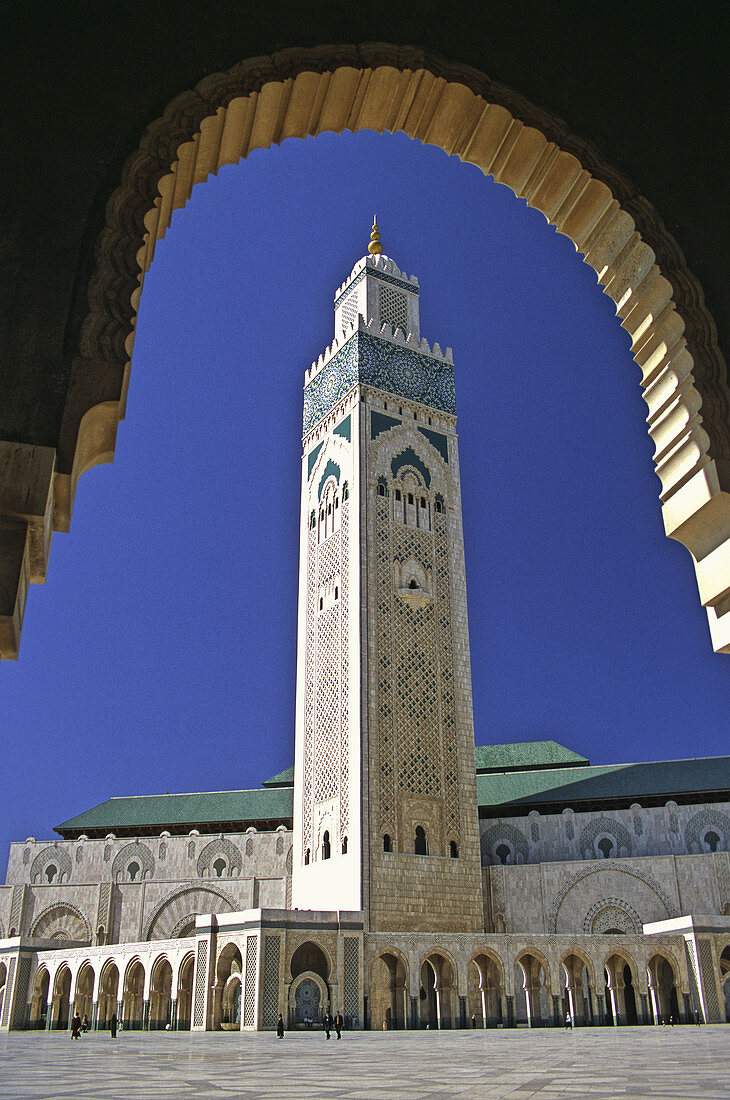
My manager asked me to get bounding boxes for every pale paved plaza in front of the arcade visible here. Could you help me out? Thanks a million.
[0,1025,730,1100]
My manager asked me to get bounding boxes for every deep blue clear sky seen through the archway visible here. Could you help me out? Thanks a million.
[0,133,730,858]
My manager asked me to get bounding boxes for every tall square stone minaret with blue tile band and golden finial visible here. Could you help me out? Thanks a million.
[292,222,484,932]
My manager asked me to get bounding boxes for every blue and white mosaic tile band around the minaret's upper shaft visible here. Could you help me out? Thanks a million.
[302,331,456,436]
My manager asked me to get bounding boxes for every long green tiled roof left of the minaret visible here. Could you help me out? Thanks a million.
[56,787,294,836]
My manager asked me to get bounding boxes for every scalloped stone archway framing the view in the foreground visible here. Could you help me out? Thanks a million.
[4,44,730,656]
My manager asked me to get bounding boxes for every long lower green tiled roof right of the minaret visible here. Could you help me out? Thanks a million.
[476,757,730,810]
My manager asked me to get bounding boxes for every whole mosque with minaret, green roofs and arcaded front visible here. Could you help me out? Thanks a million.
[0,226,730,1032]
